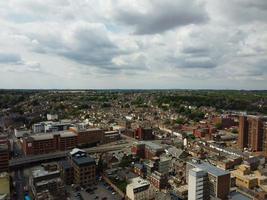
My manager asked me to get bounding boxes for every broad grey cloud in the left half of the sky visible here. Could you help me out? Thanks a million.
[31,23,122,70]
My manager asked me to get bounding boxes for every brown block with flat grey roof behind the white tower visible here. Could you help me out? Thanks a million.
[186,159,230,200]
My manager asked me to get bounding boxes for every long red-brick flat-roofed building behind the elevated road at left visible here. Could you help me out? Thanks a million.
[22,131,78,155]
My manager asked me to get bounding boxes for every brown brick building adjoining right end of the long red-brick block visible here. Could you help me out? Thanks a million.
[69,127,104,146]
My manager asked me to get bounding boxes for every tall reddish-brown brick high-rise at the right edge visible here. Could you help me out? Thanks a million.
[238,115,267,151]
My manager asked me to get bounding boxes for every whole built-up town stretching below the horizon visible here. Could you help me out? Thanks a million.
[0,90,267,200]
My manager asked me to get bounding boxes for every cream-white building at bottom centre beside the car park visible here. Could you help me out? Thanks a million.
[126,177,156,200]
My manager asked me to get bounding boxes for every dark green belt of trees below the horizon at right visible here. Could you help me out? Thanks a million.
[156,91,267,114]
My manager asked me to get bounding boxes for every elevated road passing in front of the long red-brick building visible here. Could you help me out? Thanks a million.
[9,143,130,169]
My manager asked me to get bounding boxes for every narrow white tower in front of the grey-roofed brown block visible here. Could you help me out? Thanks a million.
[188,168,209,200]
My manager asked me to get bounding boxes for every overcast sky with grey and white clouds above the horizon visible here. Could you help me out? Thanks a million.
[0,0,267,89]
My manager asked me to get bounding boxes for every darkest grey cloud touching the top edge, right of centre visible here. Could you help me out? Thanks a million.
[115,0,208,34]
